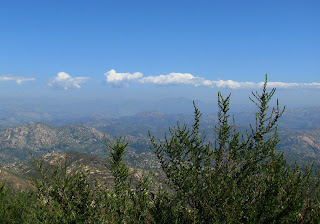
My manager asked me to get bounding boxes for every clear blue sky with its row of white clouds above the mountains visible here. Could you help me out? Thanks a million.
[0,0,320,115]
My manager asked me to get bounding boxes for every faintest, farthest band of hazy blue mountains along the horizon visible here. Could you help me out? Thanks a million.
[0,103,320,130]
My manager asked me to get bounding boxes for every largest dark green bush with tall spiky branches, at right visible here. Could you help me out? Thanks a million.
[151,76,319,223]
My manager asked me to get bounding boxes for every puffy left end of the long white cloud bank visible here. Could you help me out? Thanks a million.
[104,69,143,87]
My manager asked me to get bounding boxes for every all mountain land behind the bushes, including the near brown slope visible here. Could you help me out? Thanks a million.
[0,109,320,188]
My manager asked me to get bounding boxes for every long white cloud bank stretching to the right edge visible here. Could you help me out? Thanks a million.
[104,70,320,89]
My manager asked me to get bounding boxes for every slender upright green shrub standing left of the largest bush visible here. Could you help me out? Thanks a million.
[106,138,153,223]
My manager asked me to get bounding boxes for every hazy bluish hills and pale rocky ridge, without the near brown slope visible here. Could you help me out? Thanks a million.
[0,104,320,169]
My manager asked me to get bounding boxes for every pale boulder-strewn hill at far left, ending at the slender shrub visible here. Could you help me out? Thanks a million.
[0,122,113,162]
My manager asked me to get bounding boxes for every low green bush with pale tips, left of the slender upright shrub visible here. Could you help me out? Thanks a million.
[31,154,99,223]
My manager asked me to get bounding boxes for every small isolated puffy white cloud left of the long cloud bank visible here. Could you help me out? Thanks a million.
[48,72,89,90]
